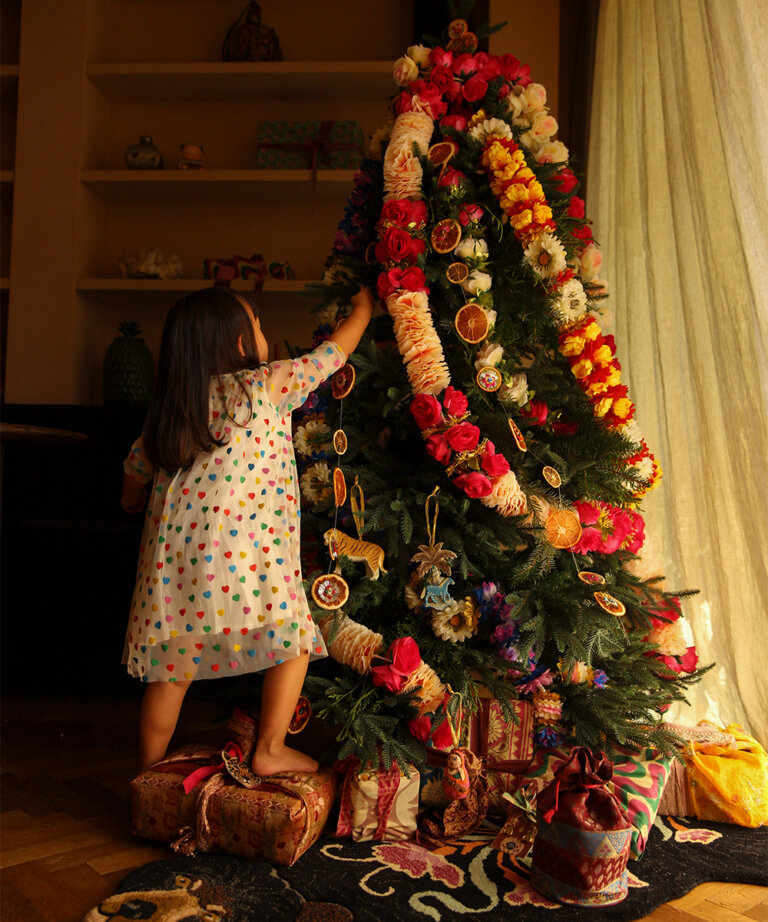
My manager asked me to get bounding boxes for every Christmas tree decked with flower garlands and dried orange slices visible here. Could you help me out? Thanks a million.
[295,12,700,766]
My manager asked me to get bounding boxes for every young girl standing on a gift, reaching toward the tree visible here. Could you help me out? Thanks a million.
[122,288,373,775]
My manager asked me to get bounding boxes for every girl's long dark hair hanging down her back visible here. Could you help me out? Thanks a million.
[143,287,260,471]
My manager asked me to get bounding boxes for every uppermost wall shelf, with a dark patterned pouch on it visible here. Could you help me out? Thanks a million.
[86,61,397,102]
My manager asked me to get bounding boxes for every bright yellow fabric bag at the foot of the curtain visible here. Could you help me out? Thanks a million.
[684,724,768,827]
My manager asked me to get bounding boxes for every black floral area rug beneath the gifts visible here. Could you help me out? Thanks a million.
[84,817,768,922]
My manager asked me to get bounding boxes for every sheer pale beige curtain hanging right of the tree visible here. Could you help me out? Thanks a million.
[587,0,768,744]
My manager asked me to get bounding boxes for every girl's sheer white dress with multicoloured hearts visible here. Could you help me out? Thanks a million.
[123,342,345,682]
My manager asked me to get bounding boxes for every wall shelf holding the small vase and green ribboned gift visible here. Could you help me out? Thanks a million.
[80,170,355,202]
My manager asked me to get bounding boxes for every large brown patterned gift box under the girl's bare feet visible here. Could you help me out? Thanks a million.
[131,746,337,865]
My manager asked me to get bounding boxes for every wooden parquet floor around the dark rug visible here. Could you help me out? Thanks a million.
[0,698,768,922]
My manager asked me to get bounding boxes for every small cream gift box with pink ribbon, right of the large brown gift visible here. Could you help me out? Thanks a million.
[336,762,419,842]
